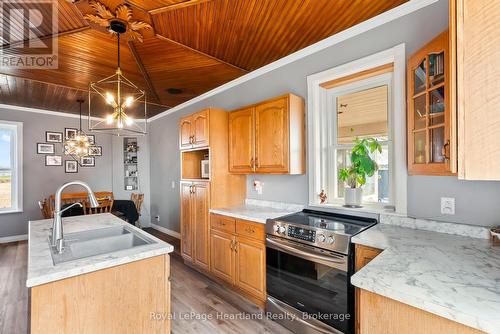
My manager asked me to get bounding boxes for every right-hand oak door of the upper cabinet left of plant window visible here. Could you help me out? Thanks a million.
[255,97,289,173]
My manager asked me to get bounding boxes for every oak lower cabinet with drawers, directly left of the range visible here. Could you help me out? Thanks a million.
[210,214,266,306]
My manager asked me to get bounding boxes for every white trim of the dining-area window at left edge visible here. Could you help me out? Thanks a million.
[0,121,23,214]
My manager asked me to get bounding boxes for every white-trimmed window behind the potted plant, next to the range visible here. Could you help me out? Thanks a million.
[307,44,407,214]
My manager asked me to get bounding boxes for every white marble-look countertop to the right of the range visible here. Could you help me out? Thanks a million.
[351,224,500,333]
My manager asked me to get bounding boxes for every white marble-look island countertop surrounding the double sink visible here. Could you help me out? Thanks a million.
[26,213,174,287]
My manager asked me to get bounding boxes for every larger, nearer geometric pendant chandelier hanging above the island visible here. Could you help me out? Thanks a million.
[89,19,147,136]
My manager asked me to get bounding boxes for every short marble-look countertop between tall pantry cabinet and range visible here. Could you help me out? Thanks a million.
[210,199,304,224]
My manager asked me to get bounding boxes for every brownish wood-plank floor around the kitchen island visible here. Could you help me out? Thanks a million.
[0,228,291,334]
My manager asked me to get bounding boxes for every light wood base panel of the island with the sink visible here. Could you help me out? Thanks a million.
[30,255,170,334]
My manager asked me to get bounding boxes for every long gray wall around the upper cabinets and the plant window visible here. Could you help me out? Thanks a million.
[150,0,500,231]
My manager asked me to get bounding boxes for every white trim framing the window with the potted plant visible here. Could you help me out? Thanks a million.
[307,43,407,214]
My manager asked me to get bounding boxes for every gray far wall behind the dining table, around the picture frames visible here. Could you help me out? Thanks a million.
[0,107,112,238]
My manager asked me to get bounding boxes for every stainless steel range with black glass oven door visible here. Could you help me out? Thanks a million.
[266,210,377,334]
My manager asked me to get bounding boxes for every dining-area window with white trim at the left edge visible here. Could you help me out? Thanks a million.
[0,120,22,213]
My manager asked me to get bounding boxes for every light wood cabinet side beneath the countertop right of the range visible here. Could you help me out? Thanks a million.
[357,289,484,334]
